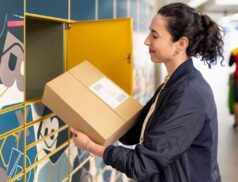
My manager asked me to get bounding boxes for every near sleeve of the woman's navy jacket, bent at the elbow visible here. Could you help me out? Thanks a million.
[103,85,205,180]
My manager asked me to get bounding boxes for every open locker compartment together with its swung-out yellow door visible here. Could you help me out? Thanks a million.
[25,16,133,101]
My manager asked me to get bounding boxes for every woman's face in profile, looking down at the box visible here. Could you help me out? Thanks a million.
[145,14,177,63]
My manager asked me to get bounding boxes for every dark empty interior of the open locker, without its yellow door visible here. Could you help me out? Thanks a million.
[25,17,64,100]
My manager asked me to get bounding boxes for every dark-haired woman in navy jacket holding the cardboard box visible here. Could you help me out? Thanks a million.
[72,3,223,182]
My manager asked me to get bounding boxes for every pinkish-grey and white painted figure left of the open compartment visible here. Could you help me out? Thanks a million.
[0,31,24,109]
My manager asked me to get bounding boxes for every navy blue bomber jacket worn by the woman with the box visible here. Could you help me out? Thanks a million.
[103,59,221,182]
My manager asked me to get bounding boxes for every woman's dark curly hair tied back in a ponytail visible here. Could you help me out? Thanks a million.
[158,3,224,67]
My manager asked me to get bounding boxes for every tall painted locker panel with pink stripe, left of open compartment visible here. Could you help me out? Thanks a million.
[0,0,24,110]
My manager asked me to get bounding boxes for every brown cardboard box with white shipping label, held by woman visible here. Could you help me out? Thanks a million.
[42,61,142,146]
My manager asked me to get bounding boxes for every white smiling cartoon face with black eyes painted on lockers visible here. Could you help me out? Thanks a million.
[37,117,59,153]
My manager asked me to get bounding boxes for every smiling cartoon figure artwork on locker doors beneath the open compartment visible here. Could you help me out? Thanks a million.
[27,103,68,182]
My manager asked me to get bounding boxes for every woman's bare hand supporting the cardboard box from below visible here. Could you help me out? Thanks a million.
[70,128,106,157]
